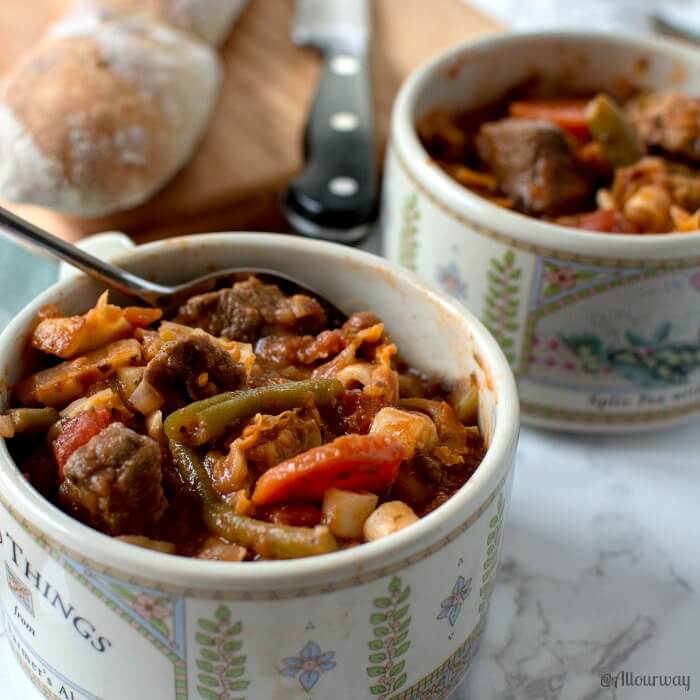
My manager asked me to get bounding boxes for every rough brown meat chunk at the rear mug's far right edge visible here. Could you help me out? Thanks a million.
[627,93,700,162]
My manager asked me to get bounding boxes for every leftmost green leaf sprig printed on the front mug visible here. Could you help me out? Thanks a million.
[195,605,250,700]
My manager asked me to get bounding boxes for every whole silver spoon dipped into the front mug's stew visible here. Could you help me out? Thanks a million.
[0,207,346,322]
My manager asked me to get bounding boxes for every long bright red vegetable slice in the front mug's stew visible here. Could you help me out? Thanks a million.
[252,435,408,505]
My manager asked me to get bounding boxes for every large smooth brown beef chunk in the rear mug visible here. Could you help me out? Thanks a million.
[477,119,591,216]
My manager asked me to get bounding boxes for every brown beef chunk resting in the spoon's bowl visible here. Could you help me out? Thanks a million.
[175,277,327,343]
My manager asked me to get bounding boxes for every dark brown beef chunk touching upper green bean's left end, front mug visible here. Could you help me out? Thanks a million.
[144,331,246,403]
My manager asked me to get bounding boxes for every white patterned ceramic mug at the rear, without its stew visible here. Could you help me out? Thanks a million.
[382,32,700,431]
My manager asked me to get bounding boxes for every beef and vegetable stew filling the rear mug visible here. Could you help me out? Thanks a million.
[417,80,700,234]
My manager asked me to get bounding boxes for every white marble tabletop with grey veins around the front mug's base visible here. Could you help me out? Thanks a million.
[0,422,700,700]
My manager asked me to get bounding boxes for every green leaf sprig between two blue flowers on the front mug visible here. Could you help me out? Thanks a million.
[367,576,411,700]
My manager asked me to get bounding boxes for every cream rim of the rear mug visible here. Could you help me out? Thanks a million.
[390,30,700,259]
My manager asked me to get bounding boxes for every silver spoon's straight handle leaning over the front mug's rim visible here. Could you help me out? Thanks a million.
[0,207,171,305]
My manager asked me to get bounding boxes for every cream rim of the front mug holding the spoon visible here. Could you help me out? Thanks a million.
[0,232,519,591]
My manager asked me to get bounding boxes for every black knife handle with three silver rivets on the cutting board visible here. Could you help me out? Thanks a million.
[285,53,377,243]
